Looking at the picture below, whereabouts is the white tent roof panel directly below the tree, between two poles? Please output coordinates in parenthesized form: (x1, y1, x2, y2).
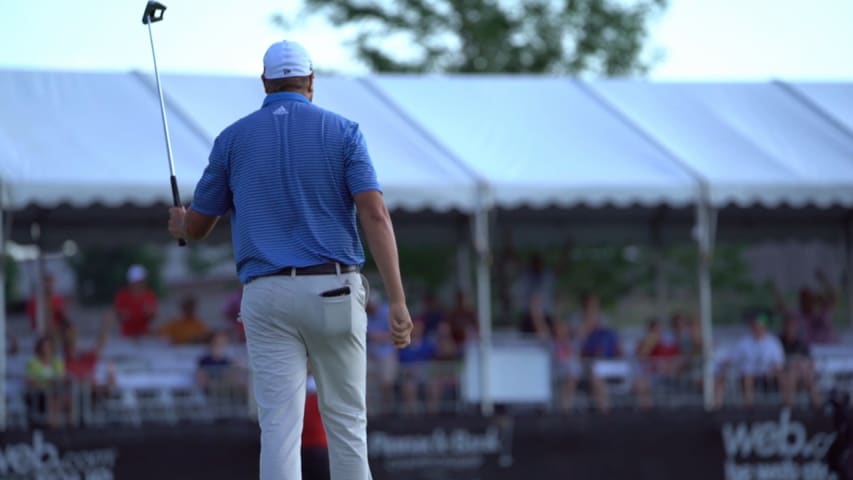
(370, 75, 696, 208)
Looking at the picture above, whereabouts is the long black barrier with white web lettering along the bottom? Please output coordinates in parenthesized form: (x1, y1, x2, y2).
(0, 408, 853, 480)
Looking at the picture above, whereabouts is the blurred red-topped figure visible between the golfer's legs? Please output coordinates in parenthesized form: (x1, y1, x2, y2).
(302, 368, 330, 480)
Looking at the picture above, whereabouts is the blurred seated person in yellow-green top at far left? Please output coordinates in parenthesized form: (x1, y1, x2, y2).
(27, 336, 71, 427)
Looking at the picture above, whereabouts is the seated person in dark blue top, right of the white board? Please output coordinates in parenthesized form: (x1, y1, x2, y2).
(581, 293, 622, 413)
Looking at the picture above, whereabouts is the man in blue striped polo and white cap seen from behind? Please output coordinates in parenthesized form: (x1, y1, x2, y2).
(169, 41, 412, 480)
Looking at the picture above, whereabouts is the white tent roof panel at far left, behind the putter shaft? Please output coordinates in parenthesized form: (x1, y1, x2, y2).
(0, 71, 208, 209)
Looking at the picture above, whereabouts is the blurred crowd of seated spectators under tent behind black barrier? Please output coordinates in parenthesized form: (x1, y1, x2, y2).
(6, 257, 853, 428)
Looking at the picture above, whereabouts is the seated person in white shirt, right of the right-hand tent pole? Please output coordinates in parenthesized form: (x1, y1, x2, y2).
(715, 311, 785, 408)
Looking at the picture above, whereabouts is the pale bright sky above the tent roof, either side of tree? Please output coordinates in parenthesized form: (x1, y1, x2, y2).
(0, 0, 853, 81)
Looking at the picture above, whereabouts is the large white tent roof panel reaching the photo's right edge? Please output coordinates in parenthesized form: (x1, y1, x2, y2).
(592, 80, 853, 207)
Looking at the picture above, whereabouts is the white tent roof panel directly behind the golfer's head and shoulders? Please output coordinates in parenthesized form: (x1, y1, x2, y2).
(151, 75, 476, 211)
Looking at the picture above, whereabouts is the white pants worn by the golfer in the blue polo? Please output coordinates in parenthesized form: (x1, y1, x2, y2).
(240, 273, 371, 480)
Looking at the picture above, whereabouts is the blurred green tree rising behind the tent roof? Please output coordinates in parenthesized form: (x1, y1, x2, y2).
(274, 0, 666, 76)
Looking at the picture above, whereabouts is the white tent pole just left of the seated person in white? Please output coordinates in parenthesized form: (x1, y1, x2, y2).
(696, 193, 717, 410)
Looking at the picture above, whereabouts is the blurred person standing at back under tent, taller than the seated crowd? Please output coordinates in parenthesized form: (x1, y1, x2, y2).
(519, 253, 555, 336)
